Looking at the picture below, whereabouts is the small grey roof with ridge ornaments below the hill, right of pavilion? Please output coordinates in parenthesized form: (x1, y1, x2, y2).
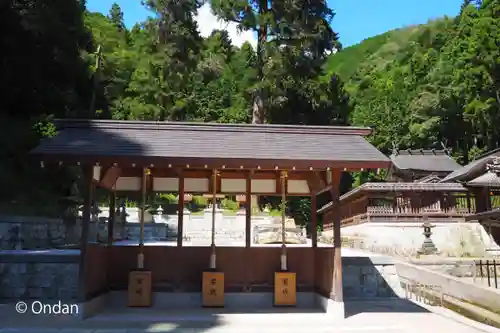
(390, 149, 461, 172)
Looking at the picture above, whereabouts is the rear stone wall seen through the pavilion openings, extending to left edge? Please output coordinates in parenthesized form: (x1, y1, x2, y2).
(0, 208, 278, 250)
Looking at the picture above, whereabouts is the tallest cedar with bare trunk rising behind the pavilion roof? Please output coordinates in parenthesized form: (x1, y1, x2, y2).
(211, 0, 336, 123)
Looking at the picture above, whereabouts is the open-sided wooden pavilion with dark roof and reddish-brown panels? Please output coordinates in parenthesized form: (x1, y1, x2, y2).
(32, 120, 390, 316)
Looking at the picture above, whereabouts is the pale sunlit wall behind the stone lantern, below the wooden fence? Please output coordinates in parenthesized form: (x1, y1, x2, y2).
(334, 220, 499, 257)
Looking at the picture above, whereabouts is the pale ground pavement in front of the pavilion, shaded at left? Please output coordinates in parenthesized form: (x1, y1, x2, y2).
(0, 300, 500, 333)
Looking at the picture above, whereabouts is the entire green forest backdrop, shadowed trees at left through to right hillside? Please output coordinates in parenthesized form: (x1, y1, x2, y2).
(0, 0, 500, 220)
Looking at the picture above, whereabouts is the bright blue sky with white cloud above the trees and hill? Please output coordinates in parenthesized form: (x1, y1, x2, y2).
(87, 0, 462, 47)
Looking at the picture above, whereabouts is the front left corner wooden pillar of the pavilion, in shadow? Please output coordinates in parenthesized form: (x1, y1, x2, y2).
(78, 166, 94, 302)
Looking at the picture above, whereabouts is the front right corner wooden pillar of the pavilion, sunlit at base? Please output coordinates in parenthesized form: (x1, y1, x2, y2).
(330, 169, 344, 302)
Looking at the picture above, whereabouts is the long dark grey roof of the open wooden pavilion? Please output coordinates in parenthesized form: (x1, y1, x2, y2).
(32, 120, 390, 169)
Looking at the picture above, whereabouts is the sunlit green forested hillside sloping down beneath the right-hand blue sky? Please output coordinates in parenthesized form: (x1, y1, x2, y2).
(327, 1, 500, 163)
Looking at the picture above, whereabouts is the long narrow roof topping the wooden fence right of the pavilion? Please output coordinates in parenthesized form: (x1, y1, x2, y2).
(318, 183, 467, 213)
